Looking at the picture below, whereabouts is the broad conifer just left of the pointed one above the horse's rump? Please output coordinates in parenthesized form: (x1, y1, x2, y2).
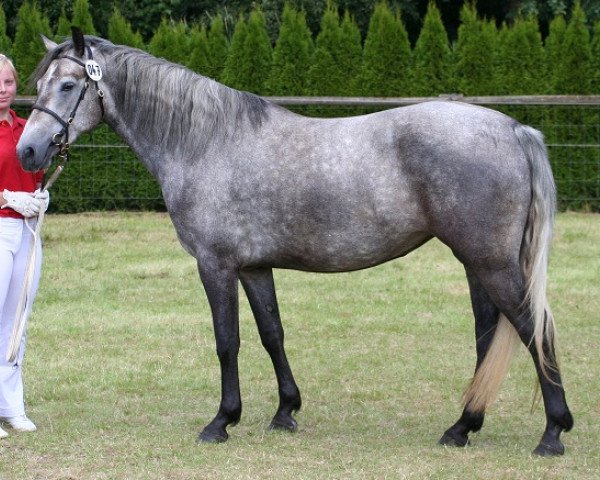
(356, 3, 411, 97)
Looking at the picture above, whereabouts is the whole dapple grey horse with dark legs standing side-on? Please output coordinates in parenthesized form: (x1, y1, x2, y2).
(18, 29, 573, 455)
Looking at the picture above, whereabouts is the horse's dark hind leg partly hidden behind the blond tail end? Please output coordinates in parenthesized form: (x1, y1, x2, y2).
(439, 269, 500, 447)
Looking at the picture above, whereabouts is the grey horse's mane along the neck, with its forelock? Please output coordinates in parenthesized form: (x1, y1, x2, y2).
(31, 35, 273, 155)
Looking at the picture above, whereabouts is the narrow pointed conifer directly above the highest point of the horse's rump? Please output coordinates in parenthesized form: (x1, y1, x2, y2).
(409, 2, 452, 96)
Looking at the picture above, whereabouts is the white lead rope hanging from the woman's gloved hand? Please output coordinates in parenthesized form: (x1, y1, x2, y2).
(6, 159, 68, 363)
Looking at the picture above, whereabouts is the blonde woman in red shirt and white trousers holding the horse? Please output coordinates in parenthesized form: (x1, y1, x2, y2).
(0, 54, 49, 438)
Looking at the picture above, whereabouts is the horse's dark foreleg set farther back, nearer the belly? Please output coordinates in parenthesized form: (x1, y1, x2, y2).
(240, 269, 302, 431)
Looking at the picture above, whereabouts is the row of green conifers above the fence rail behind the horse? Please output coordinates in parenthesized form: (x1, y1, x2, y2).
(0, 0, 600, 97)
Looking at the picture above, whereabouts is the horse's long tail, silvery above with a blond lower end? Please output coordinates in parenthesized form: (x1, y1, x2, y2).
(463, 124, 556, 412)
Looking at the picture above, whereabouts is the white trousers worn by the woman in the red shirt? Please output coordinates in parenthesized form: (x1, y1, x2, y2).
(0, 218, 42, 417)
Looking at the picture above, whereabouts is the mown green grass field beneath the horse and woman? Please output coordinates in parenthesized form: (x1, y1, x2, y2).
(0, 213, 600, 480)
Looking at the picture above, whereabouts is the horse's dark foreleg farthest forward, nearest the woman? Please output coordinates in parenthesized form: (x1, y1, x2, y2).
(198, 259, 242, 442)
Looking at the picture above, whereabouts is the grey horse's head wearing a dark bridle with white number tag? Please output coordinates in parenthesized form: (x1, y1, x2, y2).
(17, 27, 104, 171)
